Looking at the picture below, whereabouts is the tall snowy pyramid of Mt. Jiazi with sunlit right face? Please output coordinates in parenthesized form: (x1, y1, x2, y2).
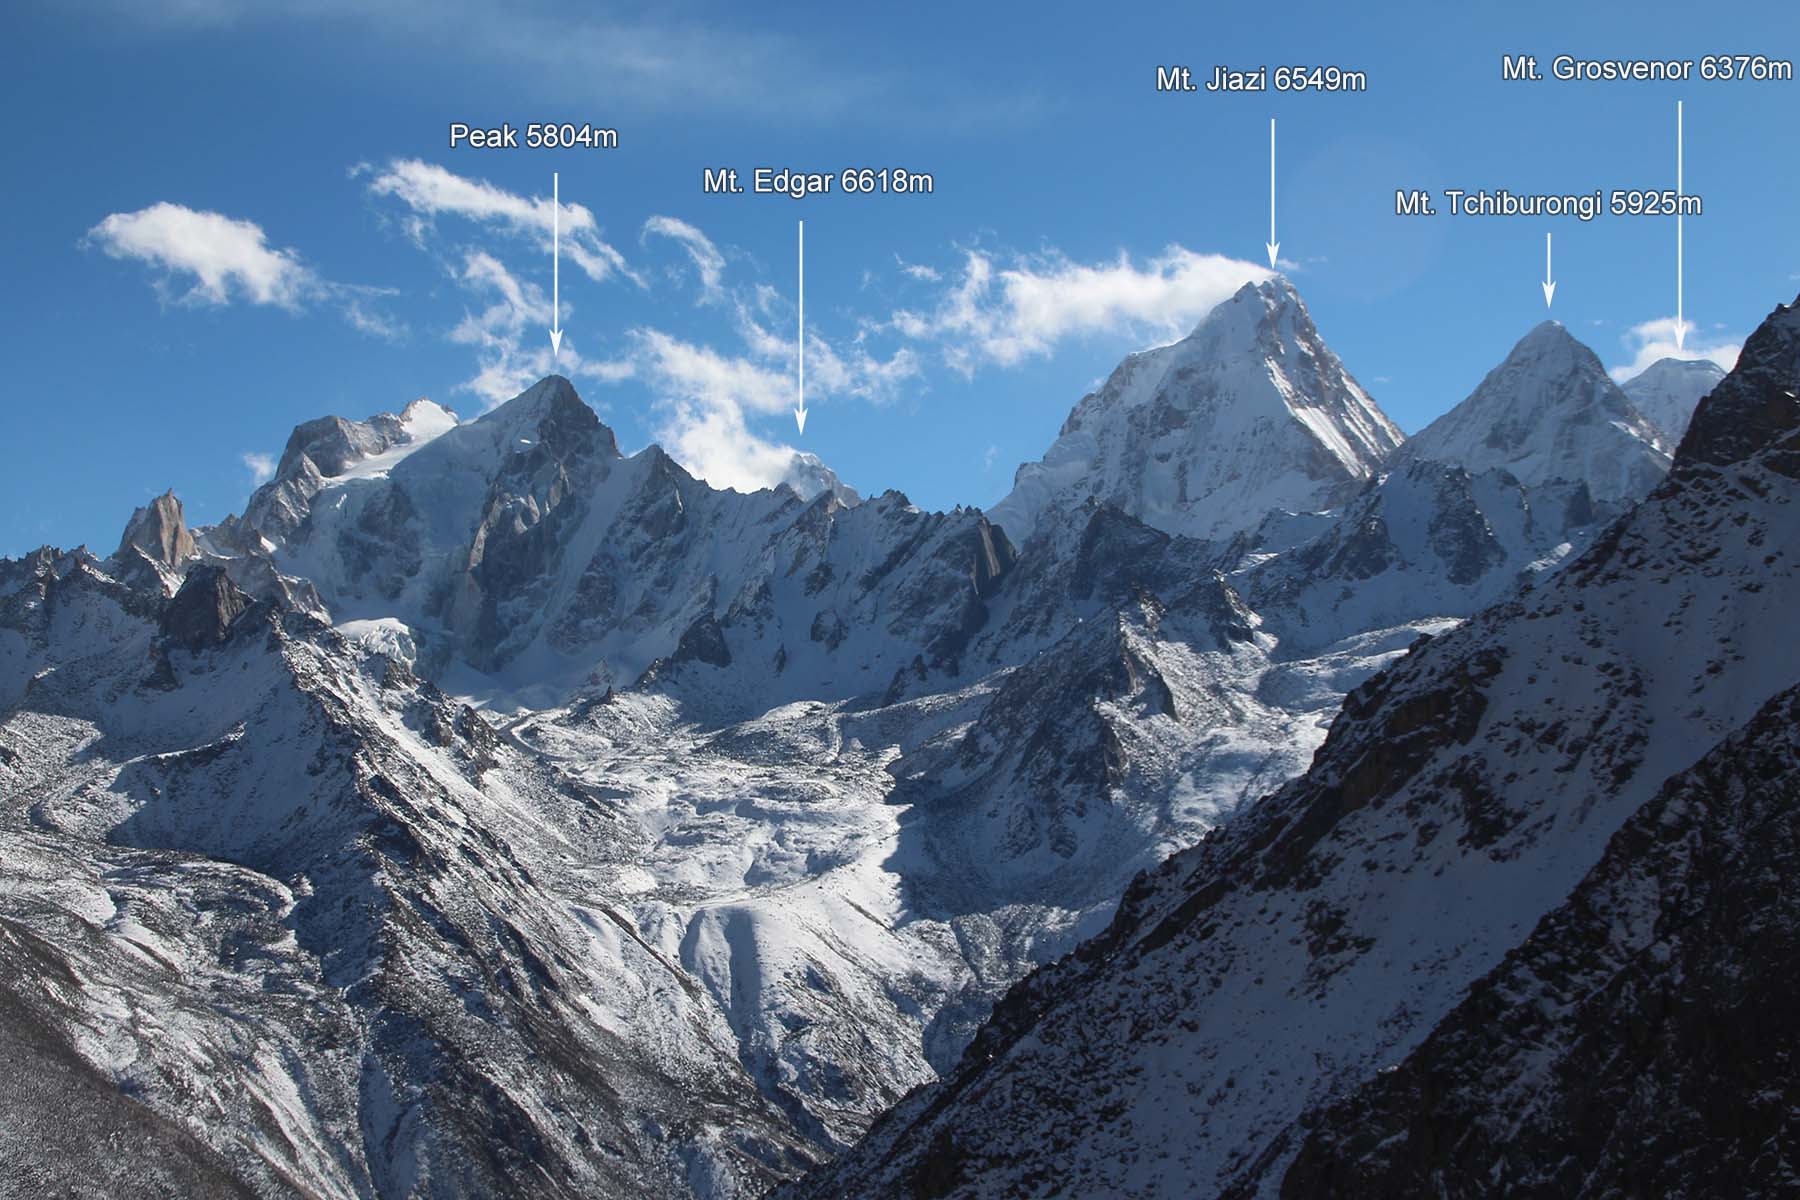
(990, 277, 1400, 545)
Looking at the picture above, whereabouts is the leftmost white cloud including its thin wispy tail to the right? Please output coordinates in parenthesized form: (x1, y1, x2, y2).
(81, 200, 405, 338)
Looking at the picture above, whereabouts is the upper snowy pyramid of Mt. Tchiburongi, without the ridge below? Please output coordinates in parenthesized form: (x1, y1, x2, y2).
(1404, 320, 1669, 500)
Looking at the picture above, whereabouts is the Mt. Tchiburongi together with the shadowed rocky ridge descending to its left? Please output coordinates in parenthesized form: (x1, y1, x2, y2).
(1237, 322, 1670, 651)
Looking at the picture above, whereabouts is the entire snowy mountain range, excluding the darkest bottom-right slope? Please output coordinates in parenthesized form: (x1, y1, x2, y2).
(0, 279, 1756, 1196)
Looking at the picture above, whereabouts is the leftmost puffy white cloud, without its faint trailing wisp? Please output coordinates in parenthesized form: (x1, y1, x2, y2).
(86, 201, 320, 311)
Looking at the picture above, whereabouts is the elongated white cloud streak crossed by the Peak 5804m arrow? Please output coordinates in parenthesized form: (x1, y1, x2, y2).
(369, 158, 643, 286)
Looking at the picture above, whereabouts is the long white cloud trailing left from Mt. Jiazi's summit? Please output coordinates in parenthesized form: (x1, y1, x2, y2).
(884, 246, 1273, 374)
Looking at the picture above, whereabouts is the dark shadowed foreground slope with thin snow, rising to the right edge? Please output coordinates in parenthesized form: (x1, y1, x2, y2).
(785, 293, 1800, 1196)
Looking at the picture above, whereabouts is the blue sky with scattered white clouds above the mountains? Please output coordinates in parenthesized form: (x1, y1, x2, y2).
(0, 0, 1800, 554)
